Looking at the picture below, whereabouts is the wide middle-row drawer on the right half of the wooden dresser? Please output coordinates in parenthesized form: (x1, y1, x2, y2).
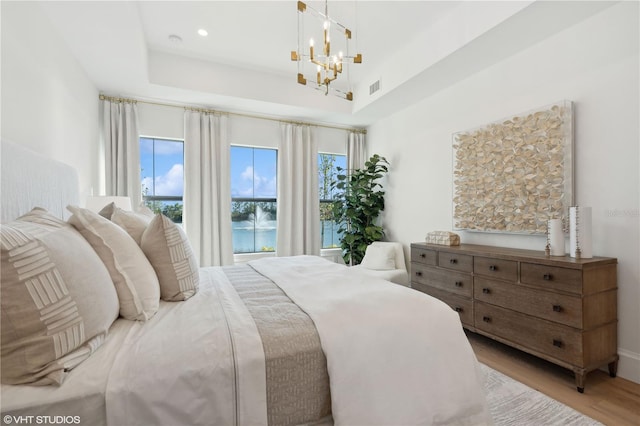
(473, 277, 582, 328)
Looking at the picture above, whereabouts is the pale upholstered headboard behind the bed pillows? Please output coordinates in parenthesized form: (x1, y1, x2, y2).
(0, 140, 79, 223)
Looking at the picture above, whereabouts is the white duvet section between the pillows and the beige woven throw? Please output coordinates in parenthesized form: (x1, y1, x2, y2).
(106, 268, 267, 426)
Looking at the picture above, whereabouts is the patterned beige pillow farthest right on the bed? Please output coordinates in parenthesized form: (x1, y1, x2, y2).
(142, 214, 199, 302)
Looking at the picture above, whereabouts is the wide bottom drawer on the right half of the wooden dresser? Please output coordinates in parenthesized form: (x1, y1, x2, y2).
(474, 302, 583, 365)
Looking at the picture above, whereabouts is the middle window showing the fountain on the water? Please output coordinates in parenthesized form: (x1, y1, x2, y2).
(231, 146, 278, 253)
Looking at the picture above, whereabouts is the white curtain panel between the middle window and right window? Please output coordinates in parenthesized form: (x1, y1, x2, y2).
(276, 123, 320, 256)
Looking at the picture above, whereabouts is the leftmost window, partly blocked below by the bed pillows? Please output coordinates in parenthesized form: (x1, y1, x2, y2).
(140, 137, 184, 223)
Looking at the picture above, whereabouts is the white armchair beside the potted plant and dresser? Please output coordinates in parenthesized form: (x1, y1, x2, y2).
(351, 241, 409, 286)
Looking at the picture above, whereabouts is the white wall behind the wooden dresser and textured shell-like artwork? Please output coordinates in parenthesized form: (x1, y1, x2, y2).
(368, 2, 640, 382)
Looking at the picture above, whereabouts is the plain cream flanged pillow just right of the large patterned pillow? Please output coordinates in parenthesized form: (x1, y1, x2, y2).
(67, 206, 160, 321)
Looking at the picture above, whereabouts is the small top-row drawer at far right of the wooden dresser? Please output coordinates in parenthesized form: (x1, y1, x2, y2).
(520, 262, 582, 294)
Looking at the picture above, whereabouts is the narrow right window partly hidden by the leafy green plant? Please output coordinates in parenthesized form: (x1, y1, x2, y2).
(318, 154, 347, 249)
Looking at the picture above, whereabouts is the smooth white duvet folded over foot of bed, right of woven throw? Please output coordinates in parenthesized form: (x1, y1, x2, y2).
(250, 256, 492, 425)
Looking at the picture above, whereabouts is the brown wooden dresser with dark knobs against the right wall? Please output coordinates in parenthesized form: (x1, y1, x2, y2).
(411, 243, 618, 392)
